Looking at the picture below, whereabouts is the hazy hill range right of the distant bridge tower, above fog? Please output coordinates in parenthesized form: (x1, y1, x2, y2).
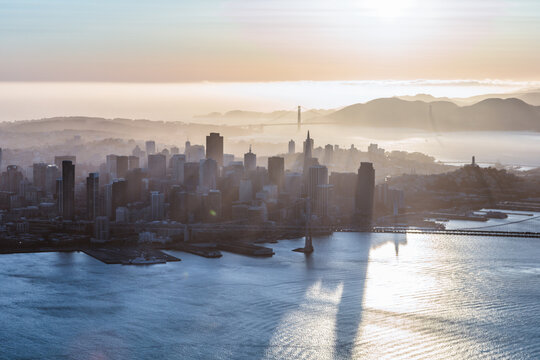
(322, 98, 540, 131)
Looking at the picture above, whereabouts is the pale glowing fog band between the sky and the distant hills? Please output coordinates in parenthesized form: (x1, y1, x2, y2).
(0, 80, 540, 121)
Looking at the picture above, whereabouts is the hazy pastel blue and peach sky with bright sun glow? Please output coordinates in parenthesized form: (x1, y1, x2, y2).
(0, 0, 540, 82)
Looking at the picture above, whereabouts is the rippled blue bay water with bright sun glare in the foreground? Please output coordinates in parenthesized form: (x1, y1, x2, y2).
(0, 233, 540, 359)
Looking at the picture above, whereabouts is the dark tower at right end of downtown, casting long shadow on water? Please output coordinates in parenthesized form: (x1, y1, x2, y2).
(355, 162, 375, 228)
